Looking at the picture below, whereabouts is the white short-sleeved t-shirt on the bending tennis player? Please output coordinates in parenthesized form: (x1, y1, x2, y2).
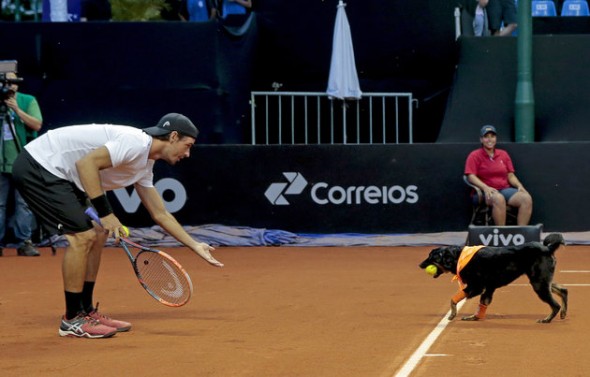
(25, 124, 154, 191)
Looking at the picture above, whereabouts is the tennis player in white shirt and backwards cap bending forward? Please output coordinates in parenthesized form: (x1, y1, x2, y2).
(13, 113, 223, 338)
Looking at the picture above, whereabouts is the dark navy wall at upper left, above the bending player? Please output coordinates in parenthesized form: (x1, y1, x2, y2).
(0, 21, 257, 144)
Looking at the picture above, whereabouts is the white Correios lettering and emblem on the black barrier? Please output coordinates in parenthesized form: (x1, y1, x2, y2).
(264, 172, 419, 205)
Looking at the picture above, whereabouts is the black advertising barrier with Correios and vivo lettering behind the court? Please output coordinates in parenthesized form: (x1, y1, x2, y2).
(109, 143, 590, 235)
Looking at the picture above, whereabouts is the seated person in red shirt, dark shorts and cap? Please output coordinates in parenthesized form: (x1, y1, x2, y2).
(465, 125, 533, 225)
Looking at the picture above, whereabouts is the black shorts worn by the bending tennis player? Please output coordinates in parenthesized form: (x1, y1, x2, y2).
(12, 149, 92, 235)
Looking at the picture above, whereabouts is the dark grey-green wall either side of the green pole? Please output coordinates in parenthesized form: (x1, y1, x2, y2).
(437, 36, 590, 143)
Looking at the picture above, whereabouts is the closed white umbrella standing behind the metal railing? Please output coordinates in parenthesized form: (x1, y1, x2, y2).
(327, 0, 362, 99)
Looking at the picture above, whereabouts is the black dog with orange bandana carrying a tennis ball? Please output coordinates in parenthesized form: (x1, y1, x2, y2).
(420, 233, 568, 323)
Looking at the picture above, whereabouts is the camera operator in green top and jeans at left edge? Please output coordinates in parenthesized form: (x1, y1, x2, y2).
(0, 72, 43, 256)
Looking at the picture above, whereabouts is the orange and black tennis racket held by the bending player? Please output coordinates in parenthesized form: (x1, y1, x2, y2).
(86, 207, 193, 307)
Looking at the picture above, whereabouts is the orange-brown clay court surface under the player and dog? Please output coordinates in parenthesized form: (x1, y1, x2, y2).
(0, 242, 590, 377)
